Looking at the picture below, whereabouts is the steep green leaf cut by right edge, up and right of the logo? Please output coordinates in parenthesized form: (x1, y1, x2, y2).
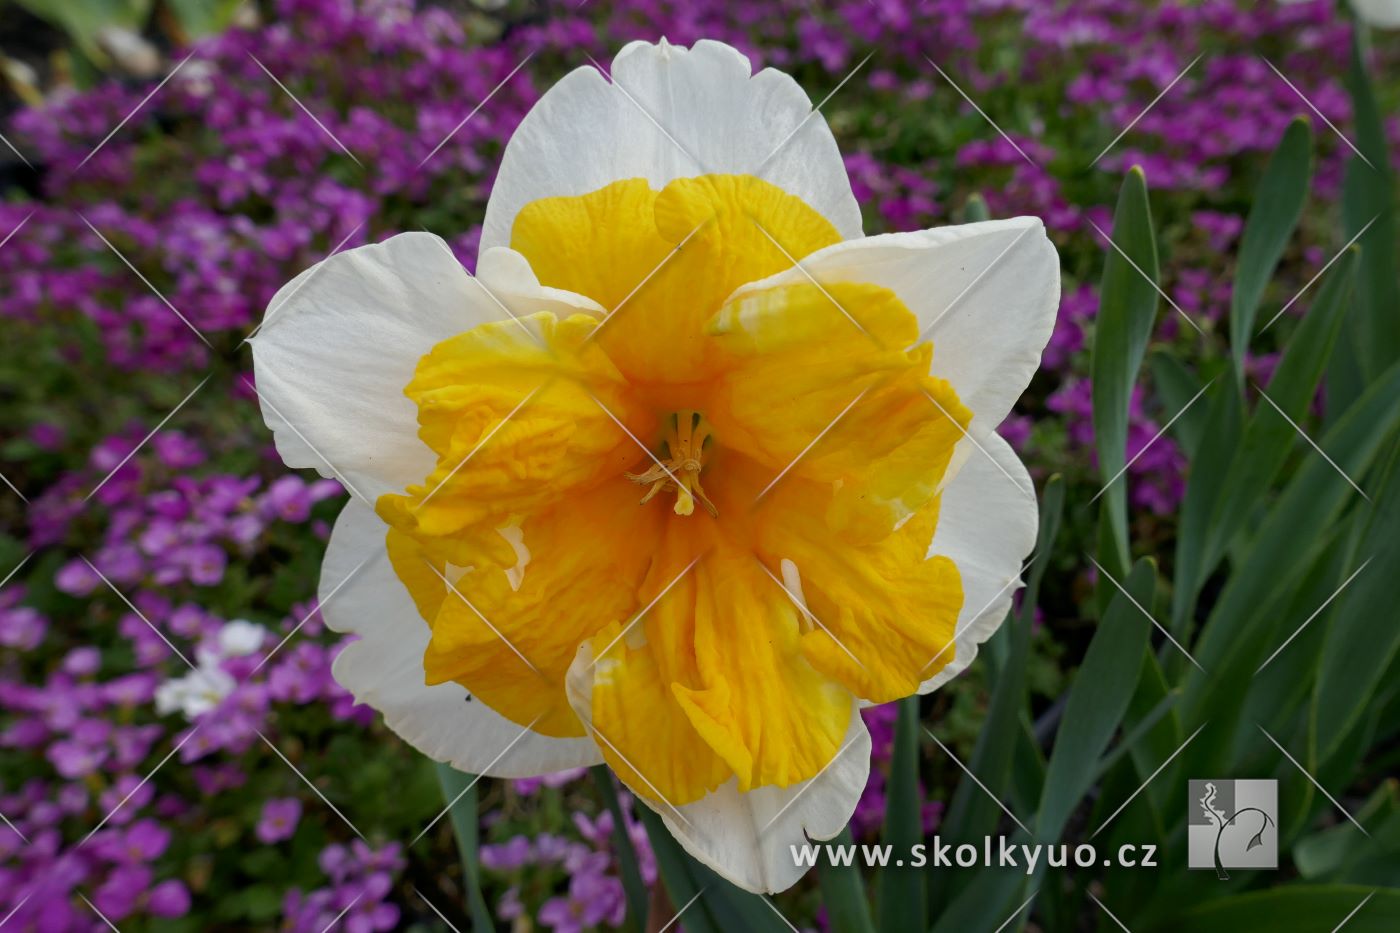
(1312, 444, 1400, 759)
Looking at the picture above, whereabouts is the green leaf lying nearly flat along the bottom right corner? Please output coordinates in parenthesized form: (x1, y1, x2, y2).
(1151, 884, 1400, 933)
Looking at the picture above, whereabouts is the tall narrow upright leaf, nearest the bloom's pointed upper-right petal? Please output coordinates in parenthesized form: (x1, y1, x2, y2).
(1091, 167, 1158, 574)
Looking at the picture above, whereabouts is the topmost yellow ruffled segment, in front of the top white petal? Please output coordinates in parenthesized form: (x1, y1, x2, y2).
(511, 175, 840, 383)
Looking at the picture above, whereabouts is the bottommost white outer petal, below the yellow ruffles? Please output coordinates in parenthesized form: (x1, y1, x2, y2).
(643, 705, 871, 894)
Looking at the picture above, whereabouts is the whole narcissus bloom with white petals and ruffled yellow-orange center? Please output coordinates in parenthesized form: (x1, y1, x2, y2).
(253, 42, 1058, 891)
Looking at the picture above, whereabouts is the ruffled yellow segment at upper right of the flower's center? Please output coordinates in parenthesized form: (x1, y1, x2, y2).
(706, 283, 972, 544)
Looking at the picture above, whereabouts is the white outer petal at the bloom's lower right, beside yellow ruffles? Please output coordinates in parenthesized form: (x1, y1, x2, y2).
(918, 430, 1039, 693)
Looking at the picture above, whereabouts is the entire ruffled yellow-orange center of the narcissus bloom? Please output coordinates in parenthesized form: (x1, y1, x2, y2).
(378, 175, 970, 806)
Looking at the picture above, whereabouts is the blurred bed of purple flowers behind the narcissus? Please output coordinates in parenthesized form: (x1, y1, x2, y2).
(0, 0, 1400, 932)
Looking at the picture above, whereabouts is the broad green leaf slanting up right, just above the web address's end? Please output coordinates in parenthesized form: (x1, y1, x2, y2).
(1036, 559, 1156, 842)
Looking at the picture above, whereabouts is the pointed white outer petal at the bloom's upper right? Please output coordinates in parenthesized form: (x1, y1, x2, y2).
(735, 217, 1060, 433)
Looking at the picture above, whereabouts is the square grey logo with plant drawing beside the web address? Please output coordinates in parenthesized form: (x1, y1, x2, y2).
(1186, 780, 1278, 880)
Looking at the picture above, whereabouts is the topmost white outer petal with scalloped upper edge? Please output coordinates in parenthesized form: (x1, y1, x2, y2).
(482, 39, 861, 249)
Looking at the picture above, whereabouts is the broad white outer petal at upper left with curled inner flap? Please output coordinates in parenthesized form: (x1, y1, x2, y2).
(252, 233, 602, 502)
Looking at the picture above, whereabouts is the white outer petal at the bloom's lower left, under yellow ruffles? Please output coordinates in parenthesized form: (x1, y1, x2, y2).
(319, 500, 602, 778)
